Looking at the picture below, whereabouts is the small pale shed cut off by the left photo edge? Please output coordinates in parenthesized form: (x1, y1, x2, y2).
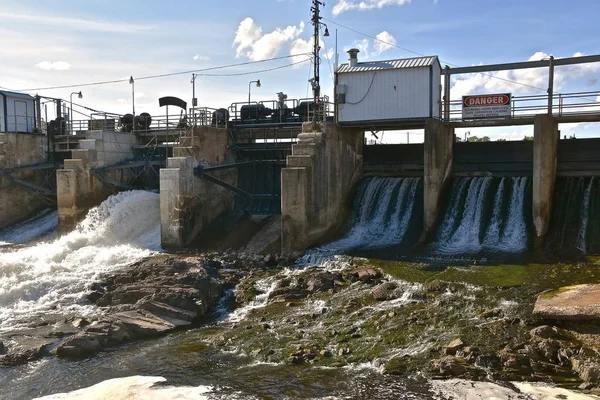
(0, 90, 35, 133)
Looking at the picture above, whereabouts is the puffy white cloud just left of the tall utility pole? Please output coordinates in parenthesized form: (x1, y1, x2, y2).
(233, 17, 304, 61)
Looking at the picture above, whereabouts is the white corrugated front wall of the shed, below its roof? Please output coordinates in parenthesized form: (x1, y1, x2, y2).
(338, 67, 432, 122)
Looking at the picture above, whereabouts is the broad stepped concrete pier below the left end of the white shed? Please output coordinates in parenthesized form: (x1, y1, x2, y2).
(281, 123, 364, 255)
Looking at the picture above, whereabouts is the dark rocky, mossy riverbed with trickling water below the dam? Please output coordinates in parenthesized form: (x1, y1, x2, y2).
(0, 253, 600, 393)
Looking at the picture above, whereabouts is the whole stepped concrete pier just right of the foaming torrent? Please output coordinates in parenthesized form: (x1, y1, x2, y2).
(160, 127, 237, 248)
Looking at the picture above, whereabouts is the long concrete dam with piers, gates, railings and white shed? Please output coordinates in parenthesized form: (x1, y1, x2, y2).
(0, 51, 600, 257)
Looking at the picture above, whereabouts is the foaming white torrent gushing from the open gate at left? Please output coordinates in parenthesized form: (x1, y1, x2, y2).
(0, 191, 160, 330)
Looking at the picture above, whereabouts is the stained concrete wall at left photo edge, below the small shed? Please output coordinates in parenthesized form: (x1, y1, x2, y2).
(0, 133, 48, 229)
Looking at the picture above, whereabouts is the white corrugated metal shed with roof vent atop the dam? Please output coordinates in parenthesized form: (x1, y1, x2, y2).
(336, 49, 442, 126)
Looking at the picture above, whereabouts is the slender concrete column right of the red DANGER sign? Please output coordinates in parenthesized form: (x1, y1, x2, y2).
(533, 115, 558, 247)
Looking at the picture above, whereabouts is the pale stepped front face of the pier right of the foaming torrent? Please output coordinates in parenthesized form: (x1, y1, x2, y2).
(160, 157, 194, 248)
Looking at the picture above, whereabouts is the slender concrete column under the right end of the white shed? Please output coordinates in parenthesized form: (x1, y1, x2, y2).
(422, 120, 454, 239)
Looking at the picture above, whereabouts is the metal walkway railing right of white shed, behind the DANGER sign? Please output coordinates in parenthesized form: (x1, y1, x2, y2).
(442, 91, 600, 122)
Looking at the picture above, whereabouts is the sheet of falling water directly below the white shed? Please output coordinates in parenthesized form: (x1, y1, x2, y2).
(303, 178, 420, 264)
